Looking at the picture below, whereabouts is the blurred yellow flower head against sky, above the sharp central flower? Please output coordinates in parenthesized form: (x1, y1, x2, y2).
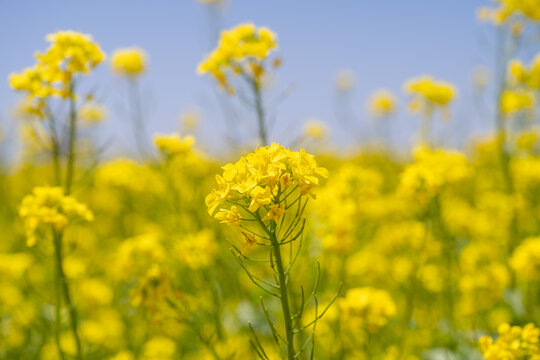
(197, 23, 277, 93)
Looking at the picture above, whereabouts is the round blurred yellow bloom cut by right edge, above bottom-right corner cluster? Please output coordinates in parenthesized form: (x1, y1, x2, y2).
(510, 237, 540, 281)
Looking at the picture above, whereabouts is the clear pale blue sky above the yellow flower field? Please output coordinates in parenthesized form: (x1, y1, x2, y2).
(0, 0, 493, 156)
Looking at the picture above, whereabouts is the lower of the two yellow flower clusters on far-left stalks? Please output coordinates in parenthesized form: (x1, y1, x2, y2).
(19, 186, 94, 246)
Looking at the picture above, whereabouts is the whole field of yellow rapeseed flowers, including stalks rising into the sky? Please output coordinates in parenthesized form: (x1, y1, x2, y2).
(0, 0, 540, 360)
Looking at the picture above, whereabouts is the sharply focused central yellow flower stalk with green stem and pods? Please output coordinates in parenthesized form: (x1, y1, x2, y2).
(206, 143, 335, 360)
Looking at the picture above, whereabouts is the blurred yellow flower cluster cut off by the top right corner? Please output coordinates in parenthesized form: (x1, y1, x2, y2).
(478, 0, 540, 25)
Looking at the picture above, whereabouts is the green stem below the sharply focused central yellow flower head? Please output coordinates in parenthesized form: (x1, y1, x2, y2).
(270, 227, 295, 360)
